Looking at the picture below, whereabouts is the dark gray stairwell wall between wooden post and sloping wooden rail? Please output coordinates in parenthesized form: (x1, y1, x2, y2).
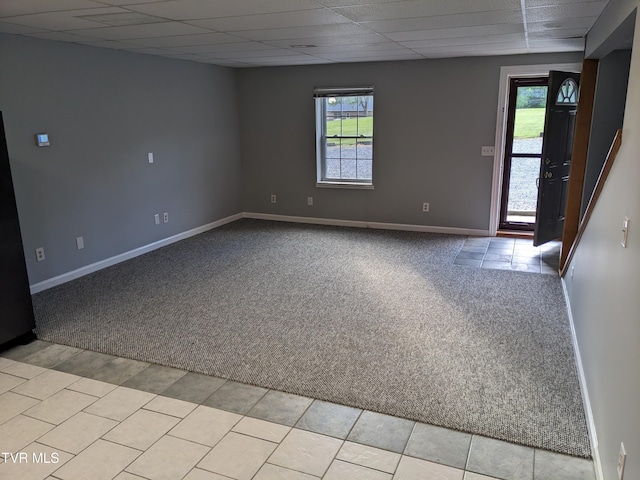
(582, 50, 631, 215)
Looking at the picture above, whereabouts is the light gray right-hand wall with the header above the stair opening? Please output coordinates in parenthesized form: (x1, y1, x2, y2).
(566, 0, 640, 480)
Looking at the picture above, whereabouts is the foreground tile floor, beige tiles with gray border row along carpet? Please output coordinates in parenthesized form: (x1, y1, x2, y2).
(0, 341, 595, 480)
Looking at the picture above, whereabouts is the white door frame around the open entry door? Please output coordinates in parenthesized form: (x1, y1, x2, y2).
(489, 63, 582, 237)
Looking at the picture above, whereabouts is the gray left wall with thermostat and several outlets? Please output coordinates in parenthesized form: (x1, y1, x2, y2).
(0, 35, 242, 284)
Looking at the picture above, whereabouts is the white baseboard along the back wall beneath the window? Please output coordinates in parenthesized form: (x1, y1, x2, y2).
(243, 212, 489, 237)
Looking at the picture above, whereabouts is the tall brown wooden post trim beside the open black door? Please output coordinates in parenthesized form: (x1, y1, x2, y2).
(560, 59, 598, 270)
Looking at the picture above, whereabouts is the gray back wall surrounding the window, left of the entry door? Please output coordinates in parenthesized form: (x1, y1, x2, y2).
(238, 53, 582, 230)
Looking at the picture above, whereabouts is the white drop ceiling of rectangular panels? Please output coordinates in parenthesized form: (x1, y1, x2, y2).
(0, 0, 607, 68)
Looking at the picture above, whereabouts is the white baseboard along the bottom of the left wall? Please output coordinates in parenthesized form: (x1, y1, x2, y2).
(31, 213, 243, 294)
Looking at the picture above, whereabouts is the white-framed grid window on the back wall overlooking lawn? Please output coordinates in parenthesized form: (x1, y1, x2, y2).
(314, 87, 373, 188)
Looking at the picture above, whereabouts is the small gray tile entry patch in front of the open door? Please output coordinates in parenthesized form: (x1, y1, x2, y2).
(454, 237, 562, 275)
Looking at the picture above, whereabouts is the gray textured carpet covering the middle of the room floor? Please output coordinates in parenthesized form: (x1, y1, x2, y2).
(34, 220, 590, 457)
